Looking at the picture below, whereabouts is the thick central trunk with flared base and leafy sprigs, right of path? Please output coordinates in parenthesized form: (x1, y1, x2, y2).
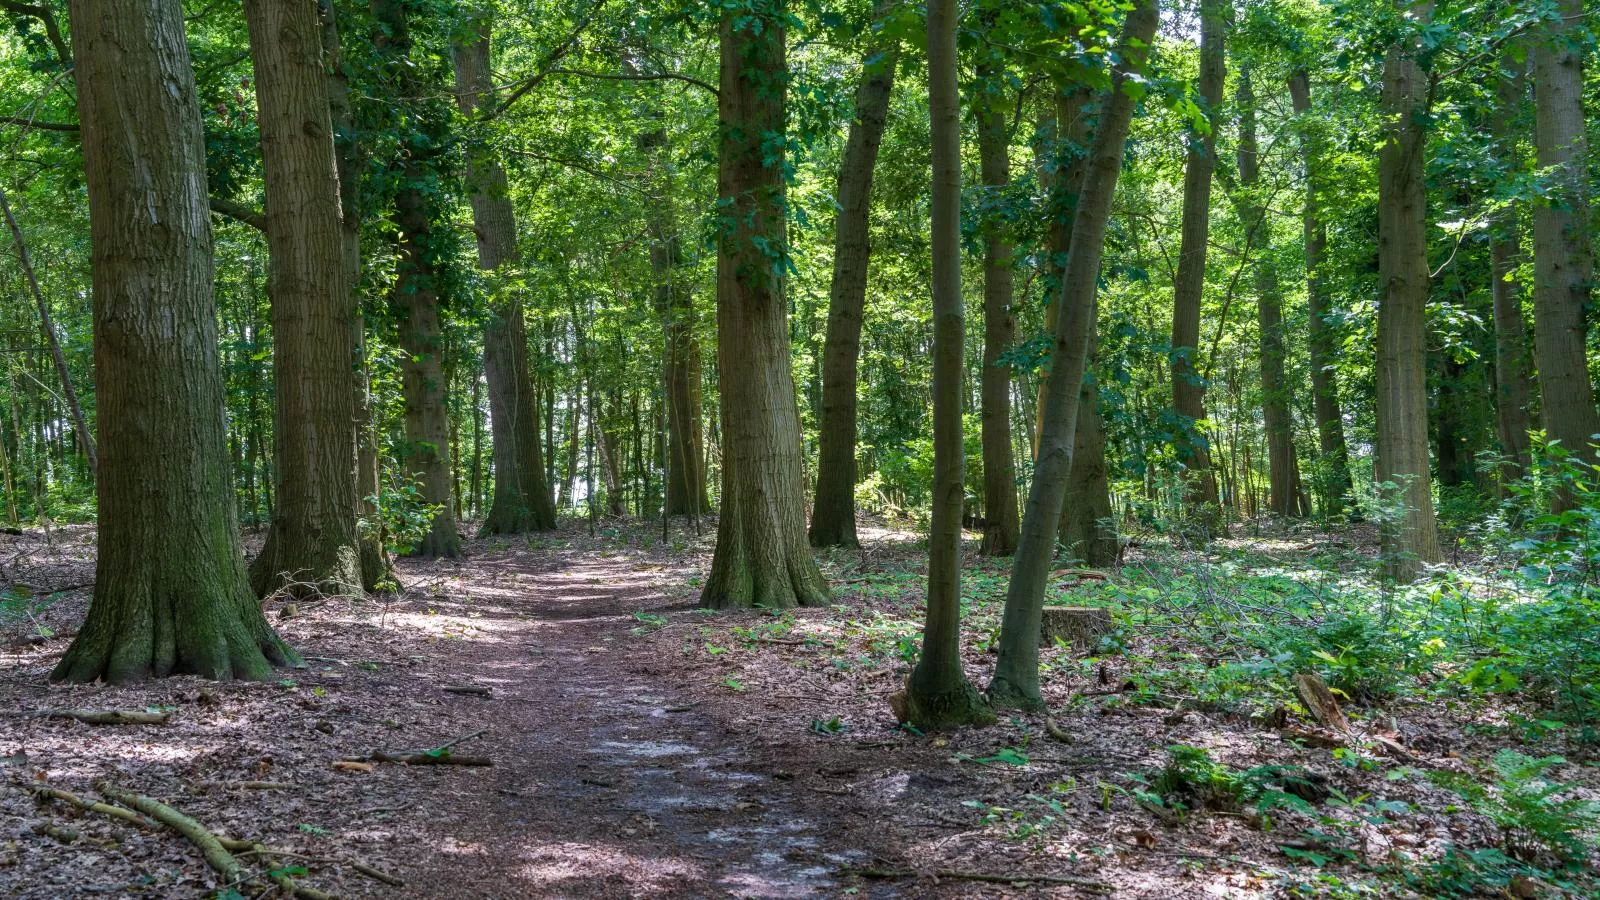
(701, 3, 827, 609)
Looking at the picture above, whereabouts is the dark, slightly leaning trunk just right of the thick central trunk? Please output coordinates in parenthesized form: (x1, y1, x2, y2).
(812, 21, 899, 546)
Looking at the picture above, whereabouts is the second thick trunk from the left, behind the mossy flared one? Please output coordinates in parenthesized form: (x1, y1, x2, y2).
(245, 0, 365, 596)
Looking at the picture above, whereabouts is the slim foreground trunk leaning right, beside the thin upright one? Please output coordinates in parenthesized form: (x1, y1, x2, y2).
(989, 0, 1160, 709)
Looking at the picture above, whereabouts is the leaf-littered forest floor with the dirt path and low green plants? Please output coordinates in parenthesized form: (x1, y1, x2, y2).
(0, 524, 1600, 898)
